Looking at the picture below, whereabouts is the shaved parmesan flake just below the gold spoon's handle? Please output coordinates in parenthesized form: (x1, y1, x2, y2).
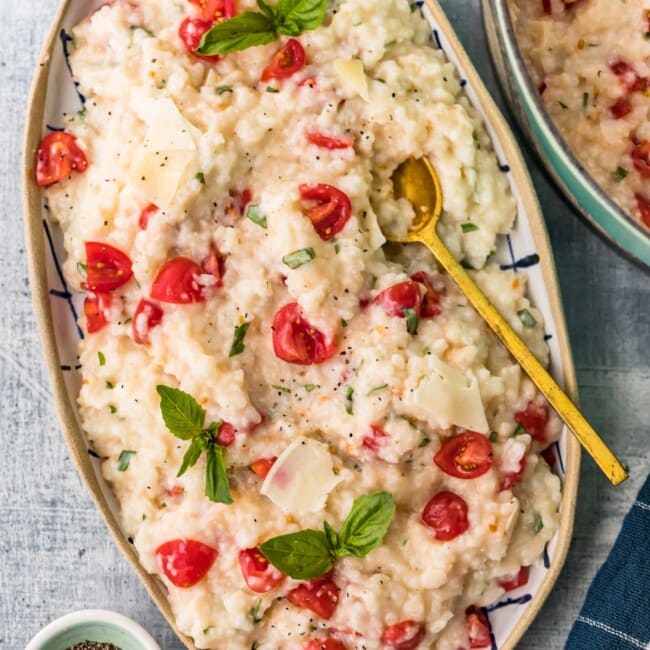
(405, 355, 489, 433)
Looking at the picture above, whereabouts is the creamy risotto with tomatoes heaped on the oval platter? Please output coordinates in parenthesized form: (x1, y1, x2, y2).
(37, 0, 560, 650)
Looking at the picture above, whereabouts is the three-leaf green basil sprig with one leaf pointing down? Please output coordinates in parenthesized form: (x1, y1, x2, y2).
(156, 384, 233, 504)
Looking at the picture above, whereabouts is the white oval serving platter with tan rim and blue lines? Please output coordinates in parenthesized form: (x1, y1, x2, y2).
(23, 0, 580, 650)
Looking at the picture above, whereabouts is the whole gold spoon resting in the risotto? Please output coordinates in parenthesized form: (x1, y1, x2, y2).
(386, 157, 627, 485)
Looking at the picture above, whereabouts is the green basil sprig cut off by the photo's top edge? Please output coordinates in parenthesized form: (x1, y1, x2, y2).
(197, 0, 327, 56)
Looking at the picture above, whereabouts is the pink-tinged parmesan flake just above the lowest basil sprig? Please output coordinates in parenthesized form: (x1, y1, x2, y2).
(260, 438, 343, 513)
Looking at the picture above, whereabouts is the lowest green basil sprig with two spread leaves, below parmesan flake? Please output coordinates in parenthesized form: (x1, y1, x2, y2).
(260, 492, 395, 580)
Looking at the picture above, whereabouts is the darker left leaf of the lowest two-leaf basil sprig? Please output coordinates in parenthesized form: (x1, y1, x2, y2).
(260, 529, 334, 580)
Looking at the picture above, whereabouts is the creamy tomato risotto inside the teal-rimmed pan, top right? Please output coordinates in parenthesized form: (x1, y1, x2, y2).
(510, 0, 650, 227)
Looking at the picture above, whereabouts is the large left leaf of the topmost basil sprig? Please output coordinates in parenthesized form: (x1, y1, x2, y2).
(197, 11, 278, 56)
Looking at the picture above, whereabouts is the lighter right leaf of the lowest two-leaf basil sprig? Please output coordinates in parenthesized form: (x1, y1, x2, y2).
(335, 492, 395, 557)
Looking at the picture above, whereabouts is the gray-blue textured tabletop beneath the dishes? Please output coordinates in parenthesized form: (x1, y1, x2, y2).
(0, 0, 650, 650)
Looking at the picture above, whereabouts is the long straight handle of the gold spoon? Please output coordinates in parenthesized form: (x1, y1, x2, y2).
(416, 228, 627, 485)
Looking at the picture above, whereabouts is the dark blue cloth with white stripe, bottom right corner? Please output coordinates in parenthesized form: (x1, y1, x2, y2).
(565, 470, 650, 650)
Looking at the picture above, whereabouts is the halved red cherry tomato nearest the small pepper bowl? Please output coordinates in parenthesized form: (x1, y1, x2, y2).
(156, 539, 218, 589)
